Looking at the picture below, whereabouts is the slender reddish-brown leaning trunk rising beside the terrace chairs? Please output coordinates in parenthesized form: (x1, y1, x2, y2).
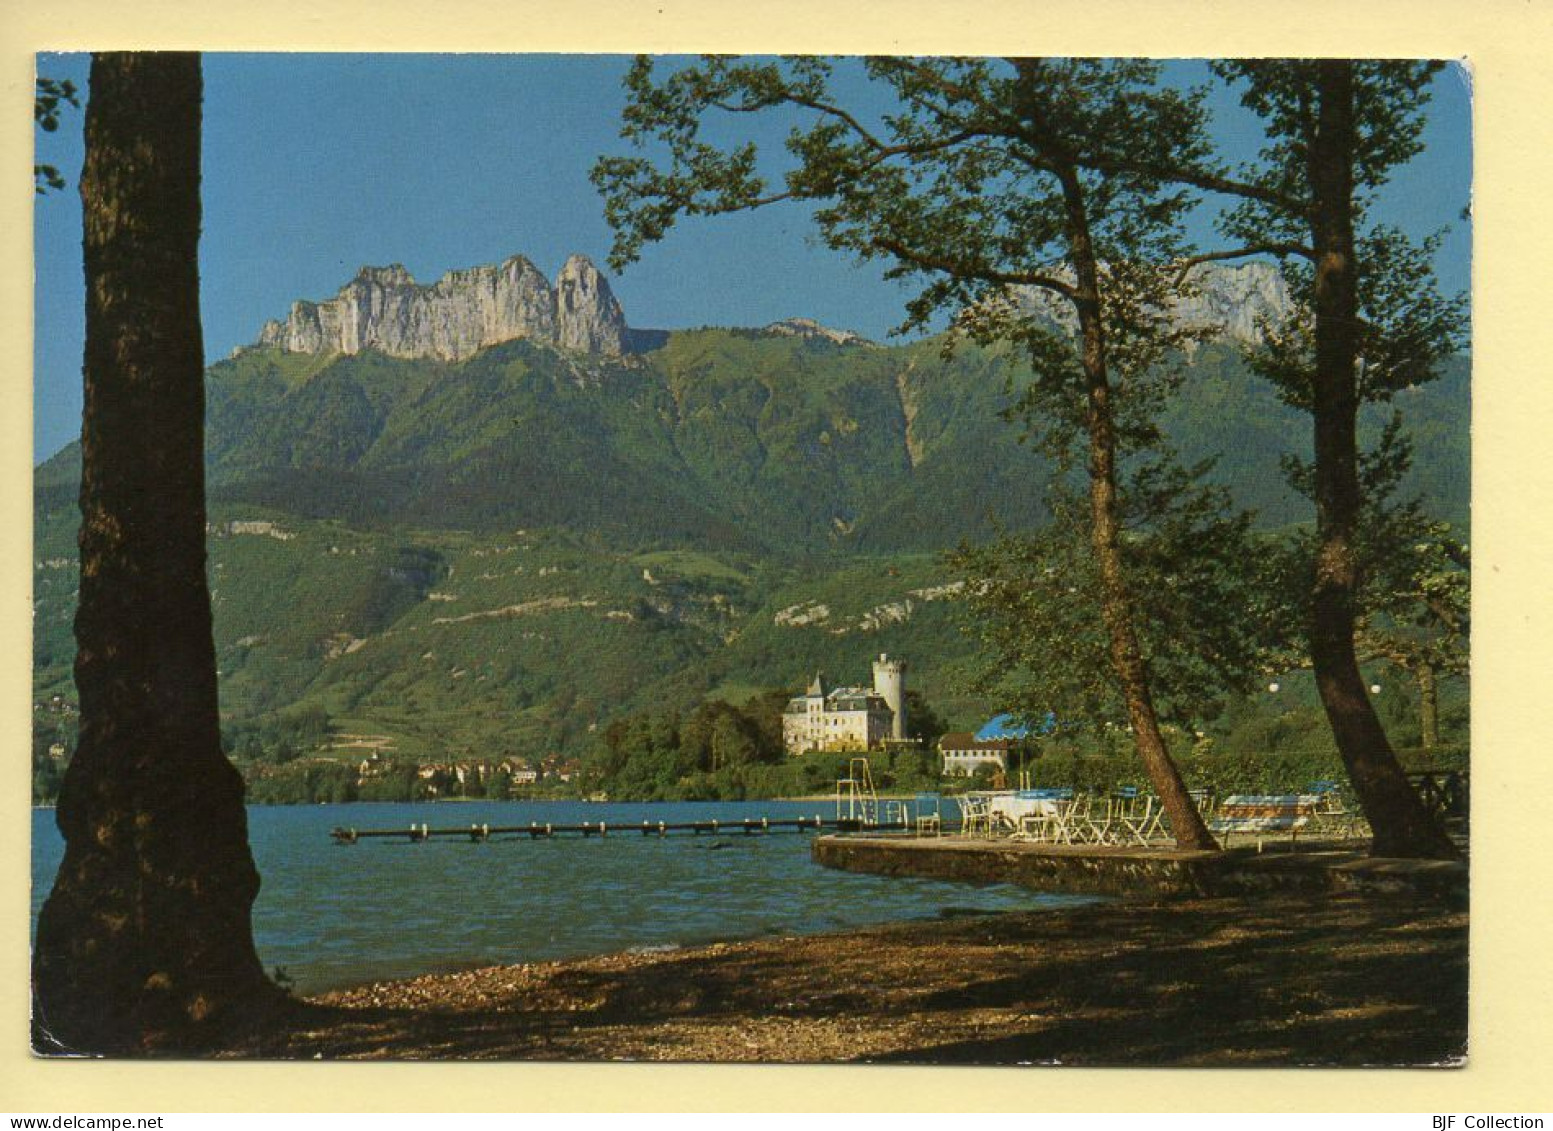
(1059, 169, 1218, 848)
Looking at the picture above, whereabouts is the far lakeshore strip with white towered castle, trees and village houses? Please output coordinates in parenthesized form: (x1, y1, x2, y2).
(33, 654, 1039, 803)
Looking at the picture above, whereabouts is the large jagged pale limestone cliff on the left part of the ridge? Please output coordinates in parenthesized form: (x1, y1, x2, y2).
(258, 255, 629, 360)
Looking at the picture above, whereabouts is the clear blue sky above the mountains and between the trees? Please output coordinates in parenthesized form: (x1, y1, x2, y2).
(34, 54, 1471, 461)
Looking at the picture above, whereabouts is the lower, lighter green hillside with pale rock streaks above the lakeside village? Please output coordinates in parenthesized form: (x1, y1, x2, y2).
(34, 505, 981, 758)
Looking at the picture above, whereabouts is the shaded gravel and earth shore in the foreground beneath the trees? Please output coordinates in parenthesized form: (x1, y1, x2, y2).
(228, 895, 1468, 1067)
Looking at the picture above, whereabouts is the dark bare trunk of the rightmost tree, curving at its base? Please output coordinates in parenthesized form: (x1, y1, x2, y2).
(1308, 61, 1458, 858)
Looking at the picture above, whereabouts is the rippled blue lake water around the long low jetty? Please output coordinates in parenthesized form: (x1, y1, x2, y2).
(33, 802, 1090, 993)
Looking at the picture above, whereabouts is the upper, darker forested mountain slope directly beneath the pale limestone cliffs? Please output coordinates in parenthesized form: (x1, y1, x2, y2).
(187, 329, 1469, 546)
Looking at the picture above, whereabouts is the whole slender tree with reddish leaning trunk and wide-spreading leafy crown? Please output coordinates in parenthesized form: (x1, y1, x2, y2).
(593, 57, 1273, 845)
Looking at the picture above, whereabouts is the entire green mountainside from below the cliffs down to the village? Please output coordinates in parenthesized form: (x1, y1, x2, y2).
(34, 329, 1469, 783)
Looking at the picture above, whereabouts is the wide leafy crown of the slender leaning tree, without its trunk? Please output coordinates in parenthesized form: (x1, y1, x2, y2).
(593, 57, 1207, 340)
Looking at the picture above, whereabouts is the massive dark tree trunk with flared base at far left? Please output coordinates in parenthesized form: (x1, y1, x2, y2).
(33, 53, 278, 1053)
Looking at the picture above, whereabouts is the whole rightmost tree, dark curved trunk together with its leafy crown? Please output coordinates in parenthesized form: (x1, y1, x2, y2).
(1180, 59, 1466, 856)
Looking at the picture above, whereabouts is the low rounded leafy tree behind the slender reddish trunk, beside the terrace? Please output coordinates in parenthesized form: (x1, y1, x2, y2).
(950, 460, 1280, 730)
